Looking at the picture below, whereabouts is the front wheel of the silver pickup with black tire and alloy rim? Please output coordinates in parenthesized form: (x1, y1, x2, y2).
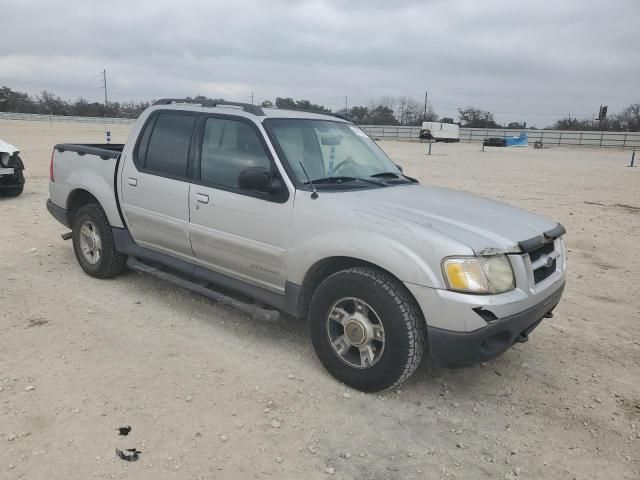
(309, 267, 426, 392)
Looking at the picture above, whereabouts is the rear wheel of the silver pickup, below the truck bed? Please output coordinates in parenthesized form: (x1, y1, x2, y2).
(72, 203, 127, 278)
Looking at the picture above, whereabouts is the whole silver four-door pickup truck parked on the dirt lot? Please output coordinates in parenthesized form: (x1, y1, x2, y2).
(47, 99, 566, 392)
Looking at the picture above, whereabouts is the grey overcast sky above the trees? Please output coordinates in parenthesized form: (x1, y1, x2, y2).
(0, 0, 640, 126)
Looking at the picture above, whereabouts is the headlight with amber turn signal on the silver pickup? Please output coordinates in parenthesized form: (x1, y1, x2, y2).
(442, 255, 515, 293)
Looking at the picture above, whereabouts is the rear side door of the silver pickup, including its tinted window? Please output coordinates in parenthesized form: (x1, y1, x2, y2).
(121, 110, 198, 257)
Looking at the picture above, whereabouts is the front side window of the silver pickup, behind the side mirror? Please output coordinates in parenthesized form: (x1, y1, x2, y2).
(200, 118, 271, 188)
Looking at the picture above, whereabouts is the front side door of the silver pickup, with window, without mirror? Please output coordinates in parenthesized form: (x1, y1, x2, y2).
(189, 115, 293, 293)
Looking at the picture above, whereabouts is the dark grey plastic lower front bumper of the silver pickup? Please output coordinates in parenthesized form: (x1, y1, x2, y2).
(427, 281, 565, 368)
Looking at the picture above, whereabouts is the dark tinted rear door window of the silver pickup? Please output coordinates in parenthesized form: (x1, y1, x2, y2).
(144, 113, 196, 177)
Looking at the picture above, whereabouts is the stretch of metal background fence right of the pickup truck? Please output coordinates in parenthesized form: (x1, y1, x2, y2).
(360, 125, 640, 148)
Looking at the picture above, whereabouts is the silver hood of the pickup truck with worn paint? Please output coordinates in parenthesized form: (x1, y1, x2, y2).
(344, 185, 557, 255)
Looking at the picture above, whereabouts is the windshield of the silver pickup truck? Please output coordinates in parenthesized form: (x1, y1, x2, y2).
(265, 119, 406, 186)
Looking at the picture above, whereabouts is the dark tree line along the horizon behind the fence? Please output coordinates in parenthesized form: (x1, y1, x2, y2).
(0, 87, 640, 132)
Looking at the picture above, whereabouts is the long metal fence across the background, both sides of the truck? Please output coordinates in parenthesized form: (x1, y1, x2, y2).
(0, 112, 640, 148)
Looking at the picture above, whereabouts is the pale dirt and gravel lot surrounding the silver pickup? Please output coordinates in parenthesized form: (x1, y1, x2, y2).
(0, 117, 640, 479)
